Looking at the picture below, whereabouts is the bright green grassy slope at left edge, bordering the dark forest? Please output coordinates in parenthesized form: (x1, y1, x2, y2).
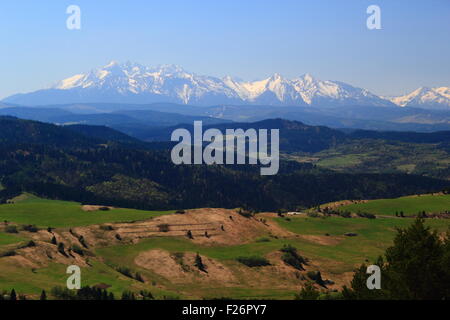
(0, 196, 172, 228)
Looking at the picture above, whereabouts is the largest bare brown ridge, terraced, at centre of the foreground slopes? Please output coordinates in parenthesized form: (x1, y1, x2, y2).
(29, 208, 312, 247)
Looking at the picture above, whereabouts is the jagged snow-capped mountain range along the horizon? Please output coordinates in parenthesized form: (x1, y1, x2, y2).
(3, 62, 450, 109)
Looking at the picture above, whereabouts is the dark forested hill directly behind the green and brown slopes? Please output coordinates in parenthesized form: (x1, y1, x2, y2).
(0, 118, 450, 210)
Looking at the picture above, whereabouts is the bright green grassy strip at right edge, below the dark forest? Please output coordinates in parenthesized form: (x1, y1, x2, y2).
(339, 194, 450, 216)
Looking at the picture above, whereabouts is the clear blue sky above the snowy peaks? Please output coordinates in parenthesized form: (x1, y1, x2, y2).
(0, 0, 450, 99)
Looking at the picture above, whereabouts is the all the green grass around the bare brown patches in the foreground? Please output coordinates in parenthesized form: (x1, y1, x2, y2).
(0, 195, 450, 299)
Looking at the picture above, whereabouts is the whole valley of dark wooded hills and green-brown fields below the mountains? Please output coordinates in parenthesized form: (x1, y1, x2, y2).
(0, 104, 450, 300)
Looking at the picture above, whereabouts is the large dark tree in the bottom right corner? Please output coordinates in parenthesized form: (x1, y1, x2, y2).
(342, 218, 450, 300)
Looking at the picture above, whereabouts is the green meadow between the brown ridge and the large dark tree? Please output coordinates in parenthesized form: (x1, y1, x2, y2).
(97, 217, 450, 272)
